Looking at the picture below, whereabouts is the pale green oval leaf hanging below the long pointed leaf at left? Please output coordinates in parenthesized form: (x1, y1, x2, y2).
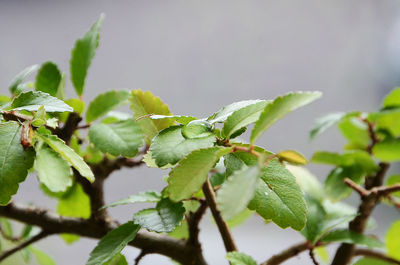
(35, 143, 72, 192)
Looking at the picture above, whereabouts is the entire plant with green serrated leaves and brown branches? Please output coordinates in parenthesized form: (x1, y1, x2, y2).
(0, 13, 400, 265)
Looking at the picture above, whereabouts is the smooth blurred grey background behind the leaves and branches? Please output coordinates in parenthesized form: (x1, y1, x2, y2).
(0, 0, 400, 265)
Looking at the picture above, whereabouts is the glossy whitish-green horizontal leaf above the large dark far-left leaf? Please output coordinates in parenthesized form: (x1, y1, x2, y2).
(11, 91, 72, 112)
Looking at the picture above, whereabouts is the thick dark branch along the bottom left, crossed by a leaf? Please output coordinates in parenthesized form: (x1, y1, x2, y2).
(0, 204, 207, 265)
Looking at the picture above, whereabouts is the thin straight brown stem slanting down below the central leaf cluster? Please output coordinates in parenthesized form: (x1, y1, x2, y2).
(203, 178, 237, 252)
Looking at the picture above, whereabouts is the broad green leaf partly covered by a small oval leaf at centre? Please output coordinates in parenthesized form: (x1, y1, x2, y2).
(150, 125, 216, 167)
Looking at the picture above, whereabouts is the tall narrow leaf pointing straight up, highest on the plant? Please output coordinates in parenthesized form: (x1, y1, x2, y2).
(70, 14, 104, 96)
